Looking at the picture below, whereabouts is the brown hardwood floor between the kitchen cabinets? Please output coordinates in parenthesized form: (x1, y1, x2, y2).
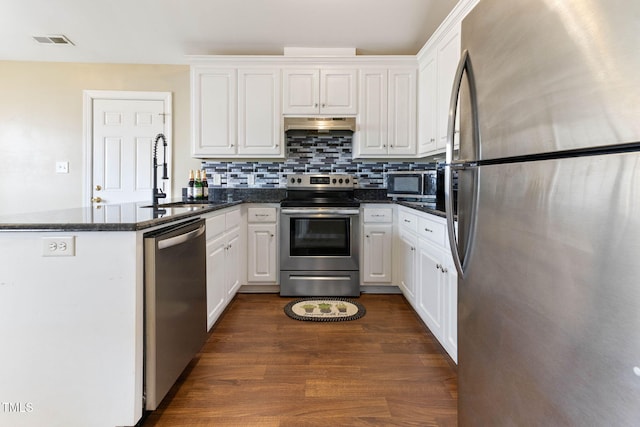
(143, 294, 457, 427)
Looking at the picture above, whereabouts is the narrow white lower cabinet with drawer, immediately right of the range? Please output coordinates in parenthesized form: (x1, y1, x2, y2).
(360, 205, 393, 285)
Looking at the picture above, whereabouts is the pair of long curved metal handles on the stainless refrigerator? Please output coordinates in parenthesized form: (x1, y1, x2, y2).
(444, 50, 480, 279)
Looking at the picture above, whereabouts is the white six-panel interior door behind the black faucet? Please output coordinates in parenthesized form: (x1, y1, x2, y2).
(89, 99, 171, 204)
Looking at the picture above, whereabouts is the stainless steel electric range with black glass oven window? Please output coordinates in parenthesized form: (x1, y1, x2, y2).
(280, 174, 360, 296)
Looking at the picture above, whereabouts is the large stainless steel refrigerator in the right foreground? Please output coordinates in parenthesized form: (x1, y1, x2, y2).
(447, 0, 640, 426)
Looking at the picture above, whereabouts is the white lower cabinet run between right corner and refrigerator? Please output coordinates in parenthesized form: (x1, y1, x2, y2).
(396, 206, 458, 363)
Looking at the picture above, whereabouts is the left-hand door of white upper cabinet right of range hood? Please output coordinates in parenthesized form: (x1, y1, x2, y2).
(353, 69, 388, 157)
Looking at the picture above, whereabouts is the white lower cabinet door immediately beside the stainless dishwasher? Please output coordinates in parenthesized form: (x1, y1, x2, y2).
(207, 236, 227, 329)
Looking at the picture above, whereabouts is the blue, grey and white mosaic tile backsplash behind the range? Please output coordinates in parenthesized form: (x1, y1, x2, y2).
(202, 132, 436, 188)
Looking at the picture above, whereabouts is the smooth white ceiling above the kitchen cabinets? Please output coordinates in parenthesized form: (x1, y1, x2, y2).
(0, 0, 457, 64)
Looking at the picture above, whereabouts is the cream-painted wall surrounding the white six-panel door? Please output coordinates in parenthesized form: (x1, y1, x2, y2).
(0, 61, 200, 215)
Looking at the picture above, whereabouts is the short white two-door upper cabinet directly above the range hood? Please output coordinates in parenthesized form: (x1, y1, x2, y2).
(282, 68, 358, 115)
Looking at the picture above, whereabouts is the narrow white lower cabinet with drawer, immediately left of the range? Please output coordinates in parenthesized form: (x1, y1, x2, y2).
(247, 207, 279, 285)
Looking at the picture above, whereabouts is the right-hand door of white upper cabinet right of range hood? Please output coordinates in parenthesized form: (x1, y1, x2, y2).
(388, 68, 416, 156)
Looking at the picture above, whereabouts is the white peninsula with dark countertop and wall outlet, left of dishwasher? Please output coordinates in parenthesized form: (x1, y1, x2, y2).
(0, 202, 241, 426)
